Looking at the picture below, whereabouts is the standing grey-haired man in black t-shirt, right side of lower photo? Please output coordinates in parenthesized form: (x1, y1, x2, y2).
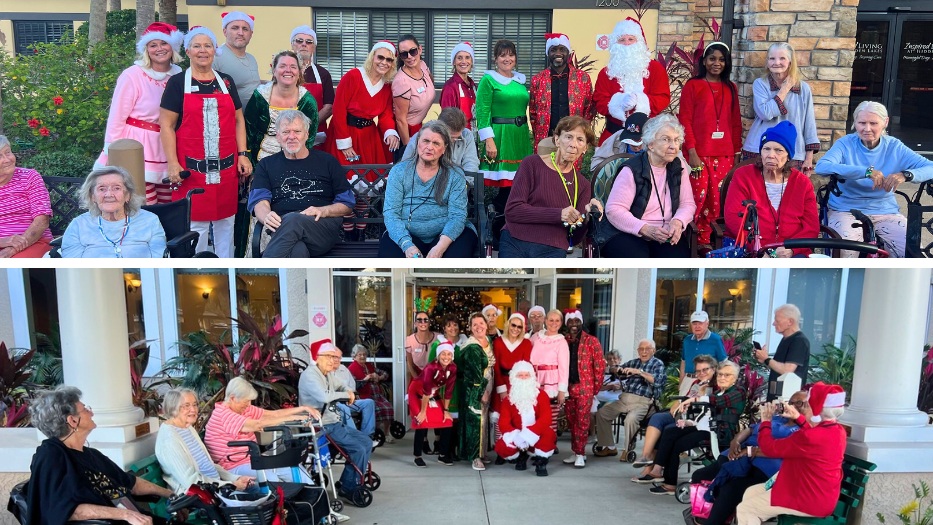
(755, 304, 810, 401)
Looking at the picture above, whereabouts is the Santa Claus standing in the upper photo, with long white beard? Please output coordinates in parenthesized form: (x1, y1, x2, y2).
(593, 17, 671, 144)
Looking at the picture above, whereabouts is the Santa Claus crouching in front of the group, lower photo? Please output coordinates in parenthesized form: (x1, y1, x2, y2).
(496, 361, 557, 476)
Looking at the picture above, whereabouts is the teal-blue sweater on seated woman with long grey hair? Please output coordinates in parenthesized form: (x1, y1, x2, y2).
(383, 159, 475, 251)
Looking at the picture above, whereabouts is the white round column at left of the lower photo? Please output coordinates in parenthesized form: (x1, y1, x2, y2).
(55, 268, 144, 428)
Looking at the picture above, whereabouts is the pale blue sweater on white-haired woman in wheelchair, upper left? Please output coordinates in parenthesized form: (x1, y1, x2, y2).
(62, 210, 165, 259)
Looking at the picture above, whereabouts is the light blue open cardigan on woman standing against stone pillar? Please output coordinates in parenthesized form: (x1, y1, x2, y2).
(742, 78, 820, 160)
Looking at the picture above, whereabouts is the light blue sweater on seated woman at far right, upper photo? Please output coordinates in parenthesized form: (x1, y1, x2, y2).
(815, 133, 933, 215)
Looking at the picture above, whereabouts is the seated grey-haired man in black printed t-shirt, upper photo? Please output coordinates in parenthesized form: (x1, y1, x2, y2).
(246, 110, 356, 257)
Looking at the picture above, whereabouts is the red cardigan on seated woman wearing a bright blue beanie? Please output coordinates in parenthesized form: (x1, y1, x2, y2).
(723, 165, 820, 255)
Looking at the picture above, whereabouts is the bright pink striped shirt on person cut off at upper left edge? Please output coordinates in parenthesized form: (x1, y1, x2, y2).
(0, 168, 52, 241)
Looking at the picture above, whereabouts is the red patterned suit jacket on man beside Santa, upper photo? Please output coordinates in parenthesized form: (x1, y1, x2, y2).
(528, 66, 596, 148)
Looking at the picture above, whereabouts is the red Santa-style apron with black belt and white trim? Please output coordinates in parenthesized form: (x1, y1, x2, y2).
(172, 69, 239, 221)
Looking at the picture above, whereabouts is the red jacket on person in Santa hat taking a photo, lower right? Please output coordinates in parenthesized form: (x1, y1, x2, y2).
(758, 421, 846, 517)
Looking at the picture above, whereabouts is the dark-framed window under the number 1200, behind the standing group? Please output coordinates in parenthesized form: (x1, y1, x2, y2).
(314, 9, 551, 88)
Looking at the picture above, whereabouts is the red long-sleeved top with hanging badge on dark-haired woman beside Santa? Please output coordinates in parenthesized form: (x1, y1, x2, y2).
(677, 78, 742, 157)
